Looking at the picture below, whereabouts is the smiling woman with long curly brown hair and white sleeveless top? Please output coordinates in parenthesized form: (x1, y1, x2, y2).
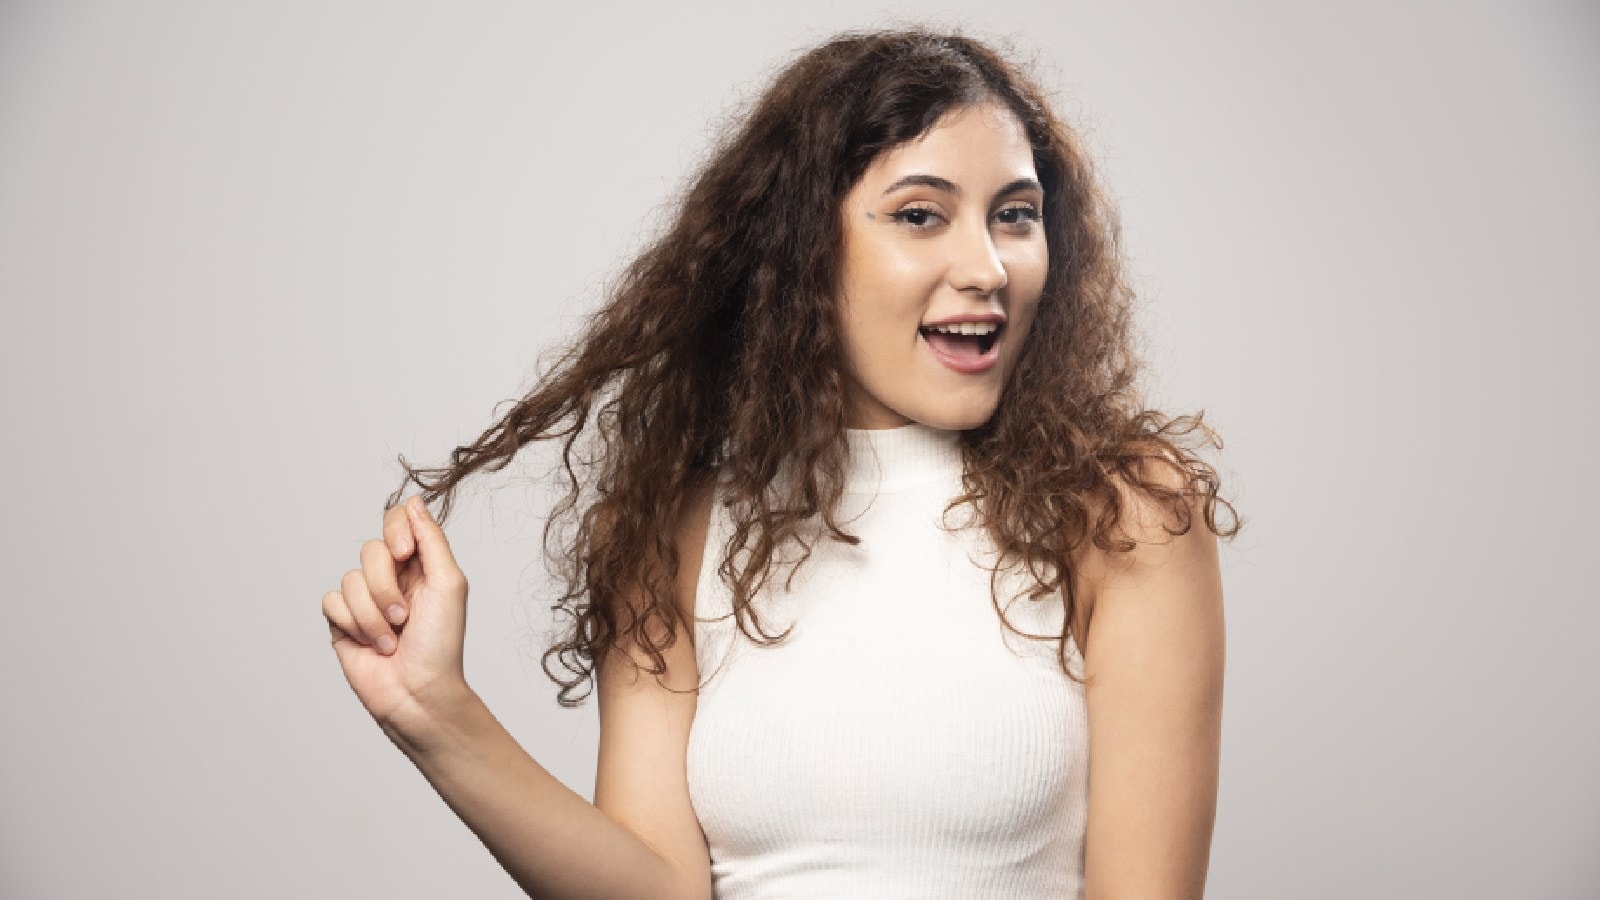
(323, 32, 1237, 897)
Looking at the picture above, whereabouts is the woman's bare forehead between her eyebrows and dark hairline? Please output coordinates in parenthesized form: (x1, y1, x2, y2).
(861, 102, 1037, 186)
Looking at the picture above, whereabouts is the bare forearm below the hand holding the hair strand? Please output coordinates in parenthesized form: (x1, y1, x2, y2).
(384, 690, 683, 898)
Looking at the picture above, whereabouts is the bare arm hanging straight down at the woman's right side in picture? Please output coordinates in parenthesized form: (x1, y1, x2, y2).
(1080, 480, 1224, 900)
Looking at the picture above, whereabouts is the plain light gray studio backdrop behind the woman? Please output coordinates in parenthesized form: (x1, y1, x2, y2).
(0, 0, 1600, 900)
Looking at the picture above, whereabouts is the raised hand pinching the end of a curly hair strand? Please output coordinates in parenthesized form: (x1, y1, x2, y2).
(322, 496, 467, 730)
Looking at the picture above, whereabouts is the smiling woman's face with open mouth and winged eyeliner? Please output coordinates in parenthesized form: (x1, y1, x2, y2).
(840, 102, 1050, 429)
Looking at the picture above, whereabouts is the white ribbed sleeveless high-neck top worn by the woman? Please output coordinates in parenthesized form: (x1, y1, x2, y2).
(688, 424, 1088, 900)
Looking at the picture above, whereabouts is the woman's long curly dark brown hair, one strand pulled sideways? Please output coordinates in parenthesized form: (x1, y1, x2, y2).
(387, 30, 1238, 706)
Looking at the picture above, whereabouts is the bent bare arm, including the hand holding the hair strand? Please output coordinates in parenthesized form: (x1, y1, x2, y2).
(323, 498, 710, 898)
